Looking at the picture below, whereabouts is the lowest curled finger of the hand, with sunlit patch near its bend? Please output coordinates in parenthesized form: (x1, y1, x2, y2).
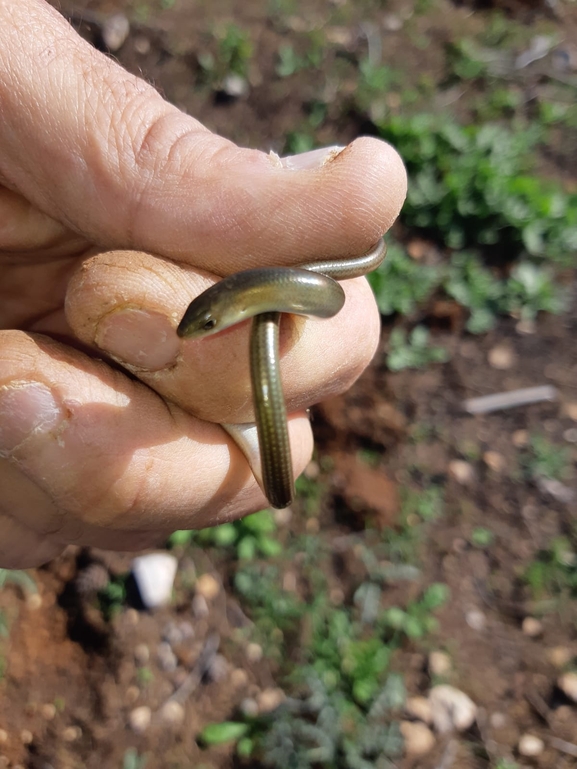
(0, 332, 312, 549)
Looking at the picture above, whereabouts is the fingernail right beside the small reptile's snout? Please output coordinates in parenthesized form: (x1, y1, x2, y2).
(95, 309, 180, 371)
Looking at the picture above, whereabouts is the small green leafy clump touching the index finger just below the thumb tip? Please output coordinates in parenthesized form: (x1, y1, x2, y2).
(368, 242, 441, 315)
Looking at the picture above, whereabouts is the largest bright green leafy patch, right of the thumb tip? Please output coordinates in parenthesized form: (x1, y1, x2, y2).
(379, 115, 577, 264)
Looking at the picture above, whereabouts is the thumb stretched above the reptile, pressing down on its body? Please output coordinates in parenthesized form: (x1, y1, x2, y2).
(0, 0, 406, 275)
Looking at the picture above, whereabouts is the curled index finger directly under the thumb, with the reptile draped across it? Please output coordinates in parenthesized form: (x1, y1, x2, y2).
(66, 251, 380, 423)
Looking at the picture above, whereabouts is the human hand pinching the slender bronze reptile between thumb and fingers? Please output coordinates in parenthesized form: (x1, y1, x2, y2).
(0, 0, 406, 568)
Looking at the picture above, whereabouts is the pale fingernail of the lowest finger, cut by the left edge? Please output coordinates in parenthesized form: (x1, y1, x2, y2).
(0, 382, 64, 456)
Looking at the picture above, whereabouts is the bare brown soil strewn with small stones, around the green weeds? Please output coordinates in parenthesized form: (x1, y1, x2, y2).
(0, 0, 577, 769)
